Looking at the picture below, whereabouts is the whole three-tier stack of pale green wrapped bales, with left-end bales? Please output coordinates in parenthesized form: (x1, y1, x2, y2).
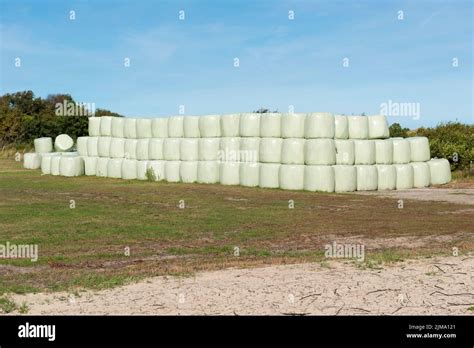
(25, 112, 451, 192)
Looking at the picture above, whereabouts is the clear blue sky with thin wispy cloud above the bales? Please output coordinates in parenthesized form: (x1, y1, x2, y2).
(0, 0, 473, 128)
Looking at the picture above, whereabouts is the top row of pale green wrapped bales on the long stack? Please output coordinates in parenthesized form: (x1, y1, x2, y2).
(89, 112, 389, 139)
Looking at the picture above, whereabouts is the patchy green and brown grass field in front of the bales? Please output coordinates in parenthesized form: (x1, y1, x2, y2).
(0, 159, 474, 294)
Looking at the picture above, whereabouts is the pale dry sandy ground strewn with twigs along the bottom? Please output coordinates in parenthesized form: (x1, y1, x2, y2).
(9, 254, 474, 315)
